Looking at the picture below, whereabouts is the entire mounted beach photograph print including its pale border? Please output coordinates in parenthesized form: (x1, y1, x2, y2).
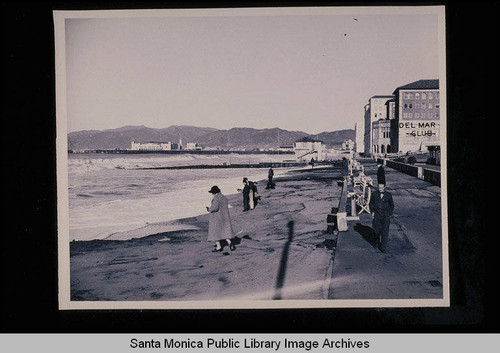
(54, 6, 450, 310)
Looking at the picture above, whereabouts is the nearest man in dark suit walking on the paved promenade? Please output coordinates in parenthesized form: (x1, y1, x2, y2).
(370, 184, 394, 253)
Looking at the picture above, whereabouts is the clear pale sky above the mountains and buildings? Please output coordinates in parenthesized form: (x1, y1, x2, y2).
(64, 10, 440, 134)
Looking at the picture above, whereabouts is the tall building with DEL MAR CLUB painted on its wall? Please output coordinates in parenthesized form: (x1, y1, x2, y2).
(392, 79, 440, 153)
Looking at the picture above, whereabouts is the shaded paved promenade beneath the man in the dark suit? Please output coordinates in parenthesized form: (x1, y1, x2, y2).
(328, 161, 446, 300)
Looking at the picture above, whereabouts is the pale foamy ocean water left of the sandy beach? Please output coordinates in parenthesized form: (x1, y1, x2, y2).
(68, 154, 290, 241)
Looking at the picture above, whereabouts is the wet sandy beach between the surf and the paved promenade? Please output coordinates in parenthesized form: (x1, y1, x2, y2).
(70, 166, 341, 301)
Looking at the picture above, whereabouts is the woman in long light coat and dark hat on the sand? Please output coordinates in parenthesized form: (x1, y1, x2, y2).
(207, 185, 235, 252)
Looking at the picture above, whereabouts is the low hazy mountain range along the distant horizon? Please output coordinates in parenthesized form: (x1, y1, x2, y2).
(68, 125, 355, 150)
